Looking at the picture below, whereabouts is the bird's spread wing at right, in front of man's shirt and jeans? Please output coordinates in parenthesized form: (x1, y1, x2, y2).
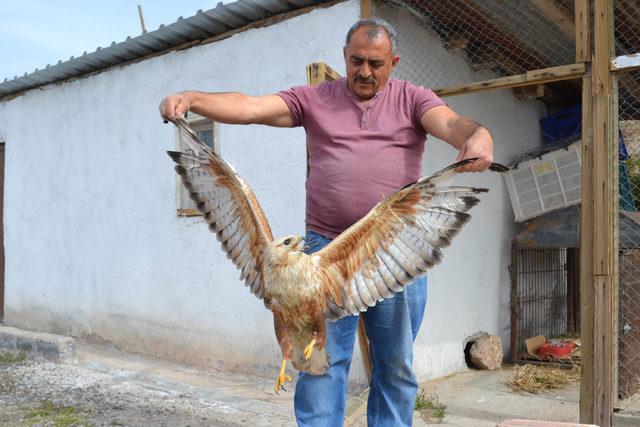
(315, 159, 508, 320)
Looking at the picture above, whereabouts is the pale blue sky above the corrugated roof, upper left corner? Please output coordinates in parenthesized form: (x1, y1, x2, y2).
(0, 0, 230, 83)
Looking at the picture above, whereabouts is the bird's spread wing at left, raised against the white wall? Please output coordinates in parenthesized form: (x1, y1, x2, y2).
(167, 118, 273, 304)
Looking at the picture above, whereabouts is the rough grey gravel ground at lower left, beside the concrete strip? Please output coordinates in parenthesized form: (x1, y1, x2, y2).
(0, 352, 292, 427)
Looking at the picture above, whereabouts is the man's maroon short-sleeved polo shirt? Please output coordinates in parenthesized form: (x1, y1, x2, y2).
(278, 78, 445, 238)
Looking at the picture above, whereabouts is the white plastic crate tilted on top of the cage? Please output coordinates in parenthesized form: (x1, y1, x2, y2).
(502, 141, 582, 222)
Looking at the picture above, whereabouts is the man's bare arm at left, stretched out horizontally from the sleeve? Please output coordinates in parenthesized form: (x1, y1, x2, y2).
(160, 91, 293, 127)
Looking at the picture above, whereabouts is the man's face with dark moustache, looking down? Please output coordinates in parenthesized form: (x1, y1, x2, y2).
(343, 26, 400, 100)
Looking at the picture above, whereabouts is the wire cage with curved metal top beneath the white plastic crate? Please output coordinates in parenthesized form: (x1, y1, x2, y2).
(510, 207, 580, 362)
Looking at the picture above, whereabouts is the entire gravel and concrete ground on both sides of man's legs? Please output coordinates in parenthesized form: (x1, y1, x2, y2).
(0, 344, 640, 427)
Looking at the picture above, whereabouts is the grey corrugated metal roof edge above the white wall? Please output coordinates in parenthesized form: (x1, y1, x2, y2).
(0, 0, 328, 99)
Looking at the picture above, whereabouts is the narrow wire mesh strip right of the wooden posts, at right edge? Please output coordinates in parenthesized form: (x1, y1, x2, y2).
(614, 0, 640, 414)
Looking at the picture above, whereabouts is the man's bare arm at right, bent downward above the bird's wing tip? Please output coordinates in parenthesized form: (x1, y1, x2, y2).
(420, 105, 493, 172)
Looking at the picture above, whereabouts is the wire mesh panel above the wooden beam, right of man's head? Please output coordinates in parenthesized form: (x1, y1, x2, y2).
(373, 0, 575, 88)
